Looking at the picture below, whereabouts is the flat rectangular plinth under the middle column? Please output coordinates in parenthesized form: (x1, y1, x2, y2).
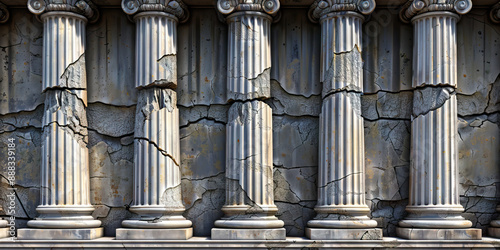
(212, 228, 286, 240)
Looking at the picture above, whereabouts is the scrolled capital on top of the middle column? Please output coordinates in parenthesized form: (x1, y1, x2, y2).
(217, 0, 280, 16)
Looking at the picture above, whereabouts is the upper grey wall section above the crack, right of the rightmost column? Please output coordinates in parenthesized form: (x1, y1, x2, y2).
(457, 9, 500, 116)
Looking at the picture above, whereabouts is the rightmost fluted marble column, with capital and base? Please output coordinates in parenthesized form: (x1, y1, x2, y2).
(396, 0, 481, 240)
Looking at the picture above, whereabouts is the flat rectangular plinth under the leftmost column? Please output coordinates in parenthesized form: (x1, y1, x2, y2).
(17, 227, 104, 240)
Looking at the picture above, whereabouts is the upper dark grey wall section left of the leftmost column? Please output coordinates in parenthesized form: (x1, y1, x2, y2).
(0, 9, 45, 115)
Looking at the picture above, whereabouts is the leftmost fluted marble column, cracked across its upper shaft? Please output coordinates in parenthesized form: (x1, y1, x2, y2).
(18, 0, 103, 239)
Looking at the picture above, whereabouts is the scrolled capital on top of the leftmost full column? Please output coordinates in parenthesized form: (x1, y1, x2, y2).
(28, 0, 99, 23)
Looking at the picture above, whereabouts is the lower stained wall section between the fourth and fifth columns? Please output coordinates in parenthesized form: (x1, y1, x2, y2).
(365, 119, 411, 236)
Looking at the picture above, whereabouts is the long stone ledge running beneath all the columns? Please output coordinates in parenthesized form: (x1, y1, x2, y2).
(0, 237, 500, 249)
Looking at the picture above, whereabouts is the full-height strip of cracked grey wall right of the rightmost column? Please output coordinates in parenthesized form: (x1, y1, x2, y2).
(456, 9, 500, 233)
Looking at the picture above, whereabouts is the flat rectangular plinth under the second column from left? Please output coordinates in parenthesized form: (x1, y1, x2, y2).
(116, 227, 193, 240)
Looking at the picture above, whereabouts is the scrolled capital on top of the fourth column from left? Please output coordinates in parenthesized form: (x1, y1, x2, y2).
(309, 0, 376, 23)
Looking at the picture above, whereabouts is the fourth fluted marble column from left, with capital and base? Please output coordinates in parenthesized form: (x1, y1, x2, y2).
(306, 0, 382, 240)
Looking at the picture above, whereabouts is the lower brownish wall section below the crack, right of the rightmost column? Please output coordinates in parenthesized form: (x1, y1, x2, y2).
(458, 113, 500, 229)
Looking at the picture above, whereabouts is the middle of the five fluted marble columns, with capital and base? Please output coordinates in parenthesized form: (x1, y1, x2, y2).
(212, 0, 286, 240)
